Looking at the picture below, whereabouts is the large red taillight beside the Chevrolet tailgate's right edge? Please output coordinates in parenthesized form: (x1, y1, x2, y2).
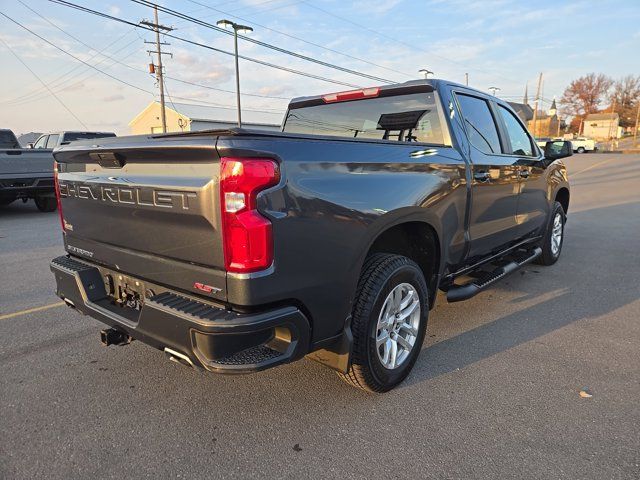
(220, 157, 280, 273)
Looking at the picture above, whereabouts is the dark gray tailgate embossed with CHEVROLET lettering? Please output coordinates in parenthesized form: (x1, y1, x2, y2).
(54, 135, 226, 300)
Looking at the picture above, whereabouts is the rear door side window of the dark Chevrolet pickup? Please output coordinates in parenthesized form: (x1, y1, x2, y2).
(456, 93, 502, 154)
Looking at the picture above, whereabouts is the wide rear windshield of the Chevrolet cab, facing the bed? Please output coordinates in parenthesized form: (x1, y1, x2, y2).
(284, 92, 449, 145)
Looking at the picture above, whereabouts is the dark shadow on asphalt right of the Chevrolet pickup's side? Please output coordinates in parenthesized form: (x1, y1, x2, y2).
(403, 202, 640, 386)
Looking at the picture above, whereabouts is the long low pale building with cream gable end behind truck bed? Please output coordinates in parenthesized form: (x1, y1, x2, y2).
(129, 101, 284, 135)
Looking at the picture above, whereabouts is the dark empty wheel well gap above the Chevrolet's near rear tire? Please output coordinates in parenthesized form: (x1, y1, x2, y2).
(367, 222, 440, 306)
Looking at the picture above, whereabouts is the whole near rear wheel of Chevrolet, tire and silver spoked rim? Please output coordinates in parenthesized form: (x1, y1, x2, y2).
(339, 253, 429, 392)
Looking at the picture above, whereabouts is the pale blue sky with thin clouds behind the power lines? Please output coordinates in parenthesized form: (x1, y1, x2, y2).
(0, 0, 640, 135)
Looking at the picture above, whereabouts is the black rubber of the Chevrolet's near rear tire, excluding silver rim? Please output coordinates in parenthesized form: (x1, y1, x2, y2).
(339, 253, 429, 392)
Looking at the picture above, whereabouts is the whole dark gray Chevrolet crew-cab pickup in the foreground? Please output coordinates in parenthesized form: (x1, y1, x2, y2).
(51, 80, 571, 392)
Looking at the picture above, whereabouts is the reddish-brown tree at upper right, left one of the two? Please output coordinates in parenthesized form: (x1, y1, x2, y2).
(560, 73, 613, 118)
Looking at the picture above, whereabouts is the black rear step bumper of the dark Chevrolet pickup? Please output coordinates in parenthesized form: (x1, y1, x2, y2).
(51, 256, 310, 373)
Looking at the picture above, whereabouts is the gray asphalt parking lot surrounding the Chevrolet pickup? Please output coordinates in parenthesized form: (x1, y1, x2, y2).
(0, 154, 640, 479)
